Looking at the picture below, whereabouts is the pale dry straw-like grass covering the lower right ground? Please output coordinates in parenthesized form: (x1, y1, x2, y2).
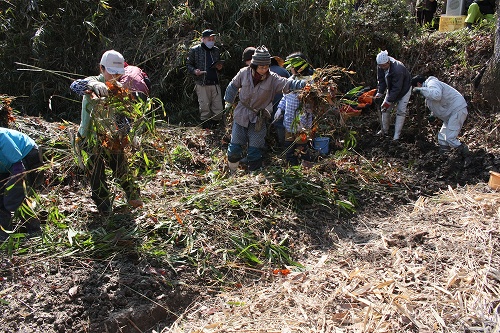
(163, 184, 500, 333)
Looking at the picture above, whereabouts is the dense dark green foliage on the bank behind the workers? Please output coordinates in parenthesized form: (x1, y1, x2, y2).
(0, 0, 416, 123)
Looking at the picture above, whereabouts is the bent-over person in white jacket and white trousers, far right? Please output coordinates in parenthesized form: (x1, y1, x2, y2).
(411, 75, 469, 156)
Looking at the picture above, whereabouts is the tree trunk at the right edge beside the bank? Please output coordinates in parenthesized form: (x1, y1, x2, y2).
(474, 6, 500, 109)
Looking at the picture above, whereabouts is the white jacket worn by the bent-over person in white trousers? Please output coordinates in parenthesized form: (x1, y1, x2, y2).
(420, 76, 467, 121)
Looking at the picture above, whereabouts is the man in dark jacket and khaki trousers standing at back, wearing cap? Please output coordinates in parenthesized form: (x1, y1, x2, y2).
(186, 29, 223, 129)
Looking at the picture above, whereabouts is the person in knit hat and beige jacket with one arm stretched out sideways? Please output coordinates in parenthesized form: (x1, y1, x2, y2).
(224, 46, 305, 172)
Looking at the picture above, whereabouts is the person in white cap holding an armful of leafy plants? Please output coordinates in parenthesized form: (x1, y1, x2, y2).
(70, 50, 149, 215)
